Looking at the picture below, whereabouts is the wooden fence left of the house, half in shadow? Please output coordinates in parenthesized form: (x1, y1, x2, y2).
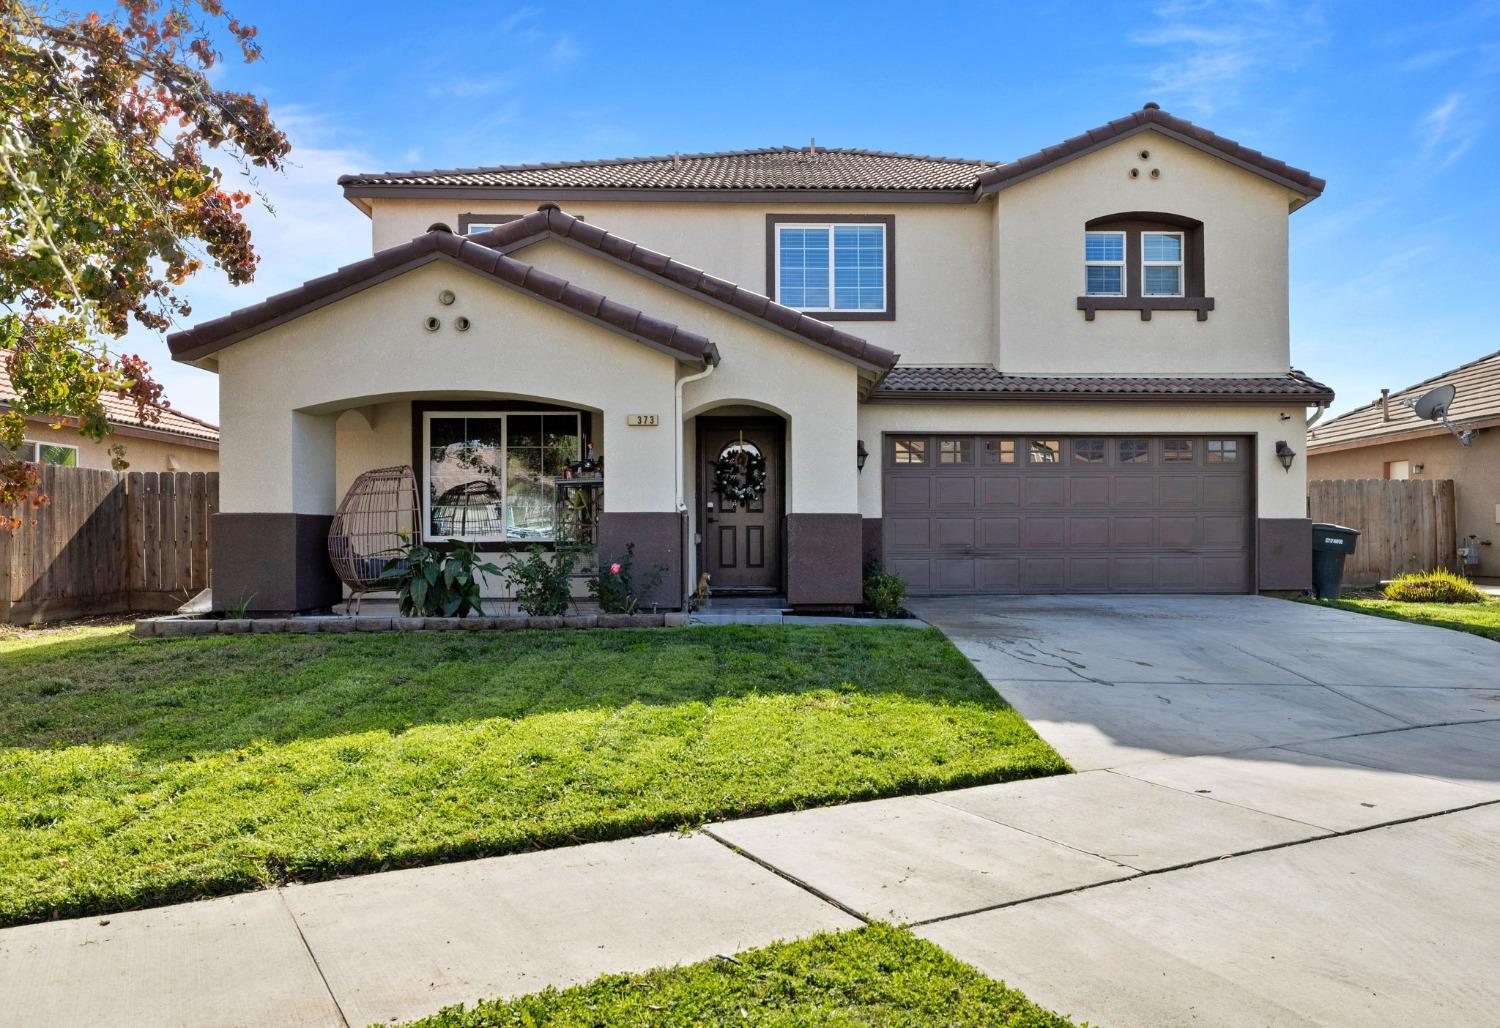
(0, 467, 219, 624)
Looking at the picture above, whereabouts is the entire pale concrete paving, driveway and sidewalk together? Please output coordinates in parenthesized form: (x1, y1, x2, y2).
(0, 597, 1500, 1026)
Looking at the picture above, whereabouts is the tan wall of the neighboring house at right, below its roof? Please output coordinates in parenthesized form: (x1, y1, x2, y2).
(1308, 429, 1500, 576)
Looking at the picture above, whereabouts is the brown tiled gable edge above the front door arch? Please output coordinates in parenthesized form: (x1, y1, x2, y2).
(468, 203, 900, 372)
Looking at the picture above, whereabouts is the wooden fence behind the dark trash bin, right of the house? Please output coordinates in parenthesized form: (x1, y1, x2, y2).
(1308, 479, 1458, 587)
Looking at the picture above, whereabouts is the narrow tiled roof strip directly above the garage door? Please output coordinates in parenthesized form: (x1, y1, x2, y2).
(870, 365, 1334, 404)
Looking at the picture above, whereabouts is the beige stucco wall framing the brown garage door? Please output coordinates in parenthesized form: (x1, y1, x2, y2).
(860, 404, 1307, 518)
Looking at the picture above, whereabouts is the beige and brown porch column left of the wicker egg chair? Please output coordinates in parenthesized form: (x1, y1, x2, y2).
(212, 408, 342, 615)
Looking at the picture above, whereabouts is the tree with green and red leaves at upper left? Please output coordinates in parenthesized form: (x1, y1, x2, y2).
(0, 0, 291, 530)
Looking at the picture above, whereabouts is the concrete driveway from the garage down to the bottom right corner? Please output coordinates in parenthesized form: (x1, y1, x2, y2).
(894, 597, 1500, 1025)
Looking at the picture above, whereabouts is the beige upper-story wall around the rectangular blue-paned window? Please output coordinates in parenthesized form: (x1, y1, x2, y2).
(369, 195, 996, 365)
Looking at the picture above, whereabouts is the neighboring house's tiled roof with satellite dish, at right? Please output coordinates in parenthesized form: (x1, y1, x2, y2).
(1308, 351, 1500, 453)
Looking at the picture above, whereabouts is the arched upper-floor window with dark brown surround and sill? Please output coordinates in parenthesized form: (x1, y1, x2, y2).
(1079, 212, 1214, 321)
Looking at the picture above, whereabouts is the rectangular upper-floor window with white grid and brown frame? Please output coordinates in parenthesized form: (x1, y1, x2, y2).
(767, 215, 896, 321)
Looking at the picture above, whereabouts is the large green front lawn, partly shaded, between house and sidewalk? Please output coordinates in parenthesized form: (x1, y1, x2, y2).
(0, 626, 1068, 924)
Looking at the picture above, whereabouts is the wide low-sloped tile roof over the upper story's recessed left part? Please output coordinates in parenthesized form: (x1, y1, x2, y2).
(339, 147, 996, 192)
